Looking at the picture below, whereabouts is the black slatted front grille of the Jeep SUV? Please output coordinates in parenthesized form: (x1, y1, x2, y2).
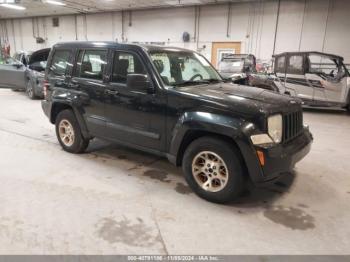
(282, 111, 303, 142)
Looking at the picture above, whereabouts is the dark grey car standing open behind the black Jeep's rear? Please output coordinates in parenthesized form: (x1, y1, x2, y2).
(0, 48, 50, 99)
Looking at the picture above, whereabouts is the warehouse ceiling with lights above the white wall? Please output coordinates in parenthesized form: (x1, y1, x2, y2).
(0, 0, 260, 19)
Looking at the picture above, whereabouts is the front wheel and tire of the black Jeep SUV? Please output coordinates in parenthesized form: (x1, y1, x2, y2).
(182, 137, 244, 203)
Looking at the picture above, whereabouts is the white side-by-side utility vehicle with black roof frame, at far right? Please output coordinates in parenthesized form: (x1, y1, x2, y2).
(269, 52, 350, 110)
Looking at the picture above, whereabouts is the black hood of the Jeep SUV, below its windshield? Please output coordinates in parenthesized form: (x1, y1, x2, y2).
(177, 83, 301, 114)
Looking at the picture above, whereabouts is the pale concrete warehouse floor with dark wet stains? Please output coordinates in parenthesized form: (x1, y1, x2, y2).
(0, 89, 350, 254)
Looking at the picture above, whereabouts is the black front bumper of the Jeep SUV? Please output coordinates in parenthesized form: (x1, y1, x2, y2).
(246, 128, 313, 184)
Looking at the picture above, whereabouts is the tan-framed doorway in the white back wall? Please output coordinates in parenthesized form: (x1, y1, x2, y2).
(211, 42, 241, 69)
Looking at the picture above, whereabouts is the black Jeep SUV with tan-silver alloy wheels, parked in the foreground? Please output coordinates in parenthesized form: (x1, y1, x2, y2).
(42, 42, 312, 203)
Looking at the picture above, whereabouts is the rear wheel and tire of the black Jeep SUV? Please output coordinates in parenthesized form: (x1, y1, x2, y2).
(55, 109, 89, 154)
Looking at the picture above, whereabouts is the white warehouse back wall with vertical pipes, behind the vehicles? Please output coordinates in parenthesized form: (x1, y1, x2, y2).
(0, 0, 350, 62)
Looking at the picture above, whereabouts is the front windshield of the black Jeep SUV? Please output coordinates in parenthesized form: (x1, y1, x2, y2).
(150, 50, 222, 86)
